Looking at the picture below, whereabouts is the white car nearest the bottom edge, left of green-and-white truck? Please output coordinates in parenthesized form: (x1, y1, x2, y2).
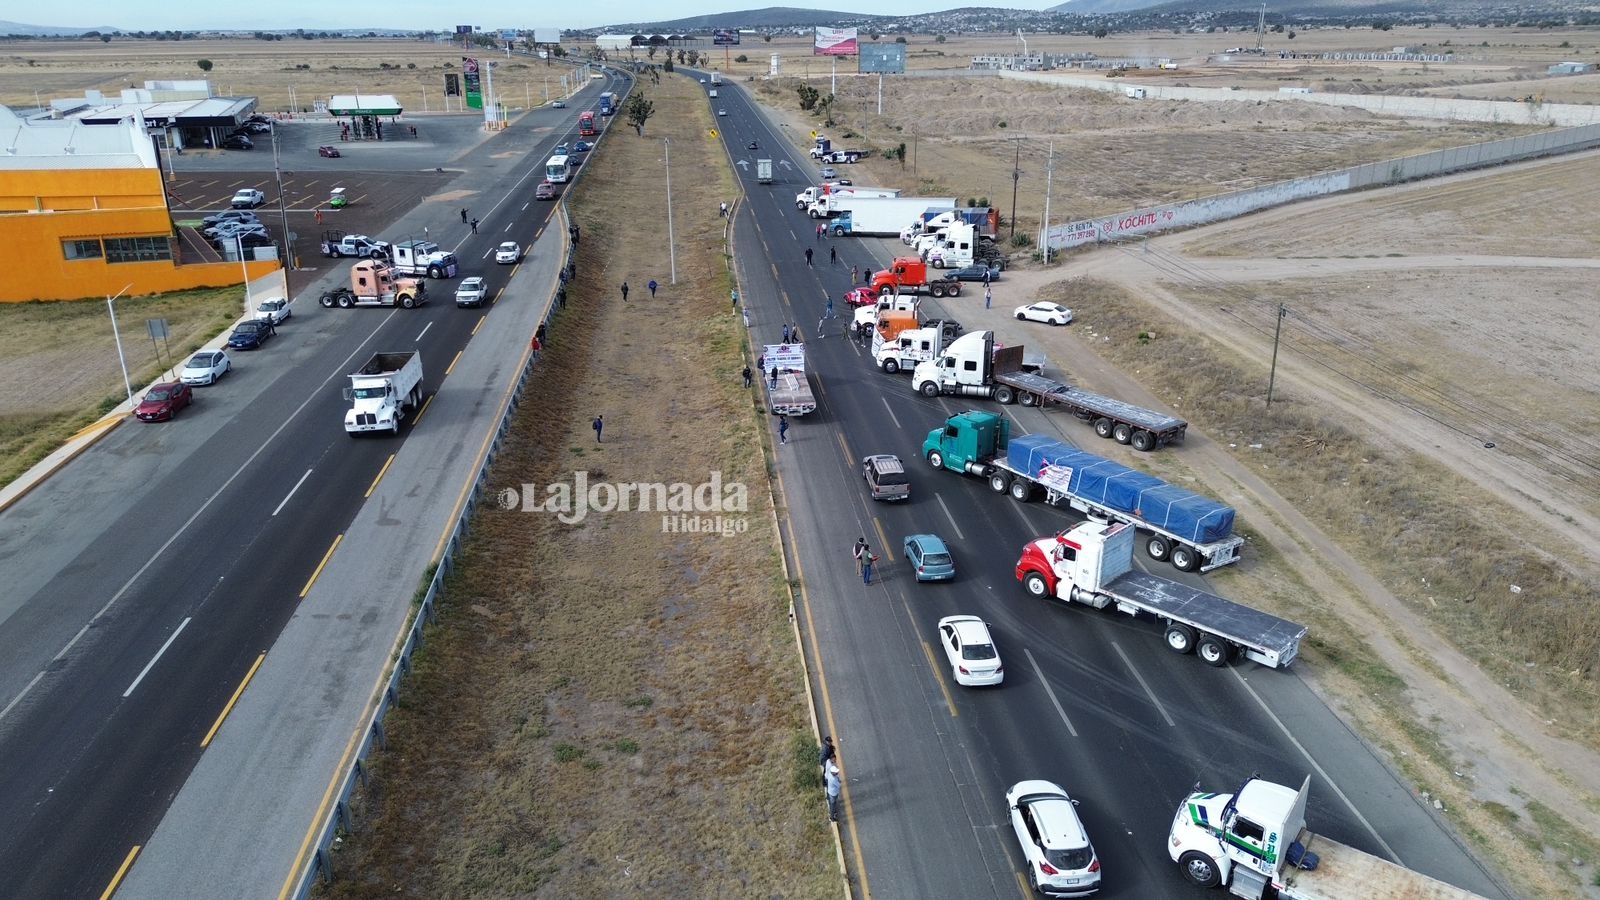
(1005, 781, 1101, 897)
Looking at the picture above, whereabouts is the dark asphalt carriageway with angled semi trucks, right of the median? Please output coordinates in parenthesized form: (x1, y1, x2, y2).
(710, 71, 1504, 898)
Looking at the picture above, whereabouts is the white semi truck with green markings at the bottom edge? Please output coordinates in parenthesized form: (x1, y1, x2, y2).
(1166, 775, 1482, 900)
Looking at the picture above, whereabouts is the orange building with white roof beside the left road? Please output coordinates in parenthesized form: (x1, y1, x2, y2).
(0, 106, 280, 303)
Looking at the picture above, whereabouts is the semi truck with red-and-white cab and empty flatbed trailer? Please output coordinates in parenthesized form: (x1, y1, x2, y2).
(1016, 520, 1305, 666)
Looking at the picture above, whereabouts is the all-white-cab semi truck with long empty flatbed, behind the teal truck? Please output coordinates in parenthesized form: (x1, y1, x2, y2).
(912, 331, 1189, 453)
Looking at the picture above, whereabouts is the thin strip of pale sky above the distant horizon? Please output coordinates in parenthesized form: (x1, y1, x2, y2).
(43, 0, 1058, 30)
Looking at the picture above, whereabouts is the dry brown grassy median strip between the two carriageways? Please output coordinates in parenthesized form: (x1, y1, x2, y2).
(316, 75, 840, 897)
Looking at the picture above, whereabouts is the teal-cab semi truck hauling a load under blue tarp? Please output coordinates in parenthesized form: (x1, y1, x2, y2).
(922, 408, 1245, 572)
